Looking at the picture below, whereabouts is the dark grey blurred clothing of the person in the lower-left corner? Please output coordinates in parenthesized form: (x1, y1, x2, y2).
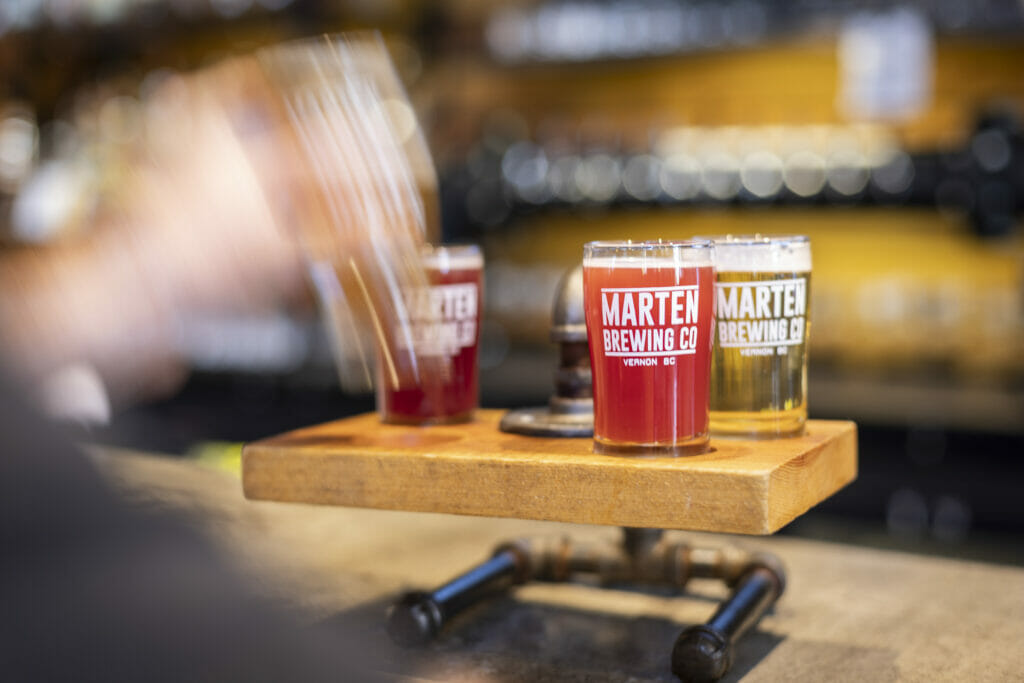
(0, 366, 393, 683)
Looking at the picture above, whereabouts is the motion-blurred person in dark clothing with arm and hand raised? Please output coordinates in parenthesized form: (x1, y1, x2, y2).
(0, 38, 436, 681)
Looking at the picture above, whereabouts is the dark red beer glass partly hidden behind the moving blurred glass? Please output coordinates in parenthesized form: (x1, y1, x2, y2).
(377, 245, 483, 424)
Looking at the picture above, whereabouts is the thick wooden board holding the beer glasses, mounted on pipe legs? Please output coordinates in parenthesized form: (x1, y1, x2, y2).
(242, 411, 857, 533)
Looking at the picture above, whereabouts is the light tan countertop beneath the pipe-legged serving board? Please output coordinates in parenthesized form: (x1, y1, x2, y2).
(97, 452, 1024, 682)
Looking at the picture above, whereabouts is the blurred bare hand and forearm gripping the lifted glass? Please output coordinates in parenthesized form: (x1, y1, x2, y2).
(0, 58, 304, 402)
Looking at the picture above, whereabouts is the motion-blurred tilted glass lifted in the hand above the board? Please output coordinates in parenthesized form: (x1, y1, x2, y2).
(256, 33, 443, 391)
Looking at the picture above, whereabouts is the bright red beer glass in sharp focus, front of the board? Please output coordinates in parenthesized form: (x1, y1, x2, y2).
(583, 241, 715, 455)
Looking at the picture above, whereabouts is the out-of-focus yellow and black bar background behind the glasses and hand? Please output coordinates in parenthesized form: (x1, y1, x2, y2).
(0, 0, 1024, 564)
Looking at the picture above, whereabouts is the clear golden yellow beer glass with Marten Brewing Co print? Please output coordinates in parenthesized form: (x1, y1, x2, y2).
(711, 236, 811, 438)
